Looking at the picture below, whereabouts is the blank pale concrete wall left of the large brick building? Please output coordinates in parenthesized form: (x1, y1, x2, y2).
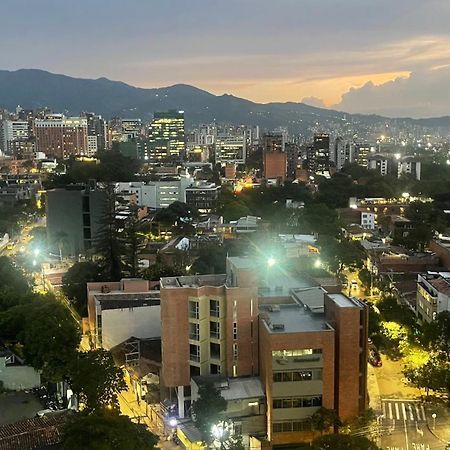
(102, 305, 161, 350)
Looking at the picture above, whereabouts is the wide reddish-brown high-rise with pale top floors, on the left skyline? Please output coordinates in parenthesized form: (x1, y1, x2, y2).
(34, 114, 88, 159)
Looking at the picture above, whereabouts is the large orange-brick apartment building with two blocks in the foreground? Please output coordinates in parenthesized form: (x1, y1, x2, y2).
(161, 257, 367, 444)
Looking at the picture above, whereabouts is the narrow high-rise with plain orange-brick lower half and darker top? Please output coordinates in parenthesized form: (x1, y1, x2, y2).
(262, 132, 287, 183)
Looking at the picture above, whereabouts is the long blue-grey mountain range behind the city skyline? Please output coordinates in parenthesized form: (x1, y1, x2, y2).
(0, 69, 450, 132)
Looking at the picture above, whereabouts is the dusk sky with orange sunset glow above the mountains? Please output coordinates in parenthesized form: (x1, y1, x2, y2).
(0, 0, 450, 117)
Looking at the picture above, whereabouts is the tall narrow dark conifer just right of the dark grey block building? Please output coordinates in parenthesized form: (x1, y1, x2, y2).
(94, 184, 123, 281)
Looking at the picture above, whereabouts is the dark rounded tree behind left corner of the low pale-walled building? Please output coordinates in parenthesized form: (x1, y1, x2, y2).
(62, 261, 102, 317)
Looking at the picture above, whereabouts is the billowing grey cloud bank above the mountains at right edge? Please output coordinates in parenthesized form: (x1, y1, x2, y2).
(333, 65, 450, 117)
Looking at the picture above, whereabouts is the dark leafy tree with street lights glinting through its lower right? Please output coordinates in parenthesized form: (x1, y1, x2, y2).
(69, 349, 127, 413)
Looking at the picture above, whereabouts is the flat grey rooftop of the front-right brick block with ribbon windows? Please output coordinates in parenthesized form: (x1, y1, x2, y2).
(260, 305, 332, 334)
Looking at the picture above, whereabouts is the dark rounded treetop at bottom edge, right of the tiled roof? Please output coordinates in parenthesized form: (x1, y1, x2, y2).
(62, 411, 158, 450)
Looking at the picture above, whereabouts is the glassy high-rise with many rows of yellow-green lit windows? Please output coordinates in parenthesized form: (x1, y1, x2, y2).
(149, 110, 186, 160)
